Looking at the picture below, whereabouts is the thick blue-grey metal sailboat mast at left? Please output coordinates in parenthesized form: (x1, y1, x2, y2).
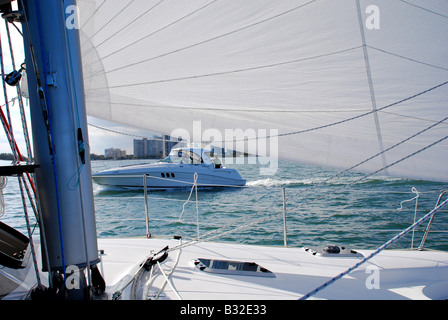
(18, 0, 99, 296)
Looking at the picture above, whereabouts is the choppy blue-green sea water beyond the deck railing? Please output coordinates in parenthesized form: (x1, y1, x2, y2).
(0, 158, 448, 250)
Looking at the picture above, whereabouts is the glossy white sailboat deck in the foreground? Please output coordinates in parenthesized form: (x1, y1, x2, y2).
(99, 238, 448, 300)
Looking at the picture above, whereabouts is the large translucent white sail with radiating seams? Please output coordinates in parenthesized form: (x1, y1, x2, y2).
(78, 0, 448, 181)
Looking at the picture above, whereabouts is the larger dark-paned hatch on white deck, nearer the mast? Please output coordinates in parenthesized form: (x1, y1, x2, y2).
(193, 258, 275, 278)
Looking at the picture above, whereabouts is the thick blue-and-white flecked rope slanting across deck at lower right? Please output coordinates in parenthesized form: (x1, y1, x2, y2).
(299, 195, 448, 300)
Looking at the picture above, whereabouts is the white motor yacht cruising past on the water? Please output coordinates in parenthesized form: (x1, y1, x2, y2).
(93, 147, 246, 190)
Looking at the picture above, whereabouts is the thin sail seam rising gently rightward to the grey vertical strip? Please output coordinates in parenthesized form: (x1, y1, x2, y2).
(105, 46, 363, 88)
